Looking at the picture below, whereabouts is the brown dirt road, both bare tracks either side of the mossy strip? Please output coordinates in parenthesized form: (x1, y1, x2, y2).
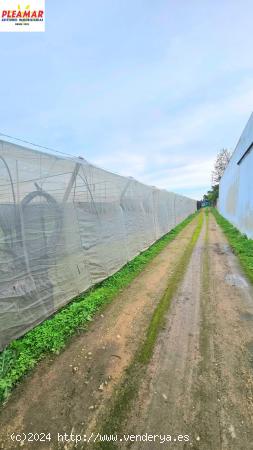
(0, 212, 253, 450)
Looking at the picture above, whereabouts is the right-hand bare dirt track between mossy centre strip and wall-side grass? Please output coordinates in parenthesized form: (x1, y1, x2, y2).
(123, 216, 253, 450)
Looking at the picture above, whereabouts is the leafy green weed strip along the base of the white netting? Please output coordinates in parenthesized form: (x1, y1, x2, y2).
(0, 213, 197, 402)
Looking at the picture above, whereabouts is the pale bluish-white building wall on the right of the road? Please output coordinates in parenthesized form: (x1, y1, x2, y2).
(218, 114, 253, 238)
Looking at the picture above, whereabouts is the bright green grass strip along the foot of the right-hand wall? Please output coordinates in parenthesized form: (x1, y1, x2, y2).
(212, 208, 253, 283)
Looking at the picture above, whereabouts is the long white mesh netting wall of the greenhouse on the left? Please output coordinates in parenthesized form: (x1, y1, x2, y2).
(0, 141, 196, 350)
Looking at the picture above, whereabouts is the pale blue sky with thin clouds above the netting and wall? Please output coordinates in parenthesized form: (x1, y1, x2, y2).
(0, 0, 253, 198)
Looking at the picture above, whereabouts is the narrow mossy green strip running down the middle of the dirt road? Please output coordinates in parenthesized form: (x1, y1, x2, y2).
(97, 214, 203, 449)
